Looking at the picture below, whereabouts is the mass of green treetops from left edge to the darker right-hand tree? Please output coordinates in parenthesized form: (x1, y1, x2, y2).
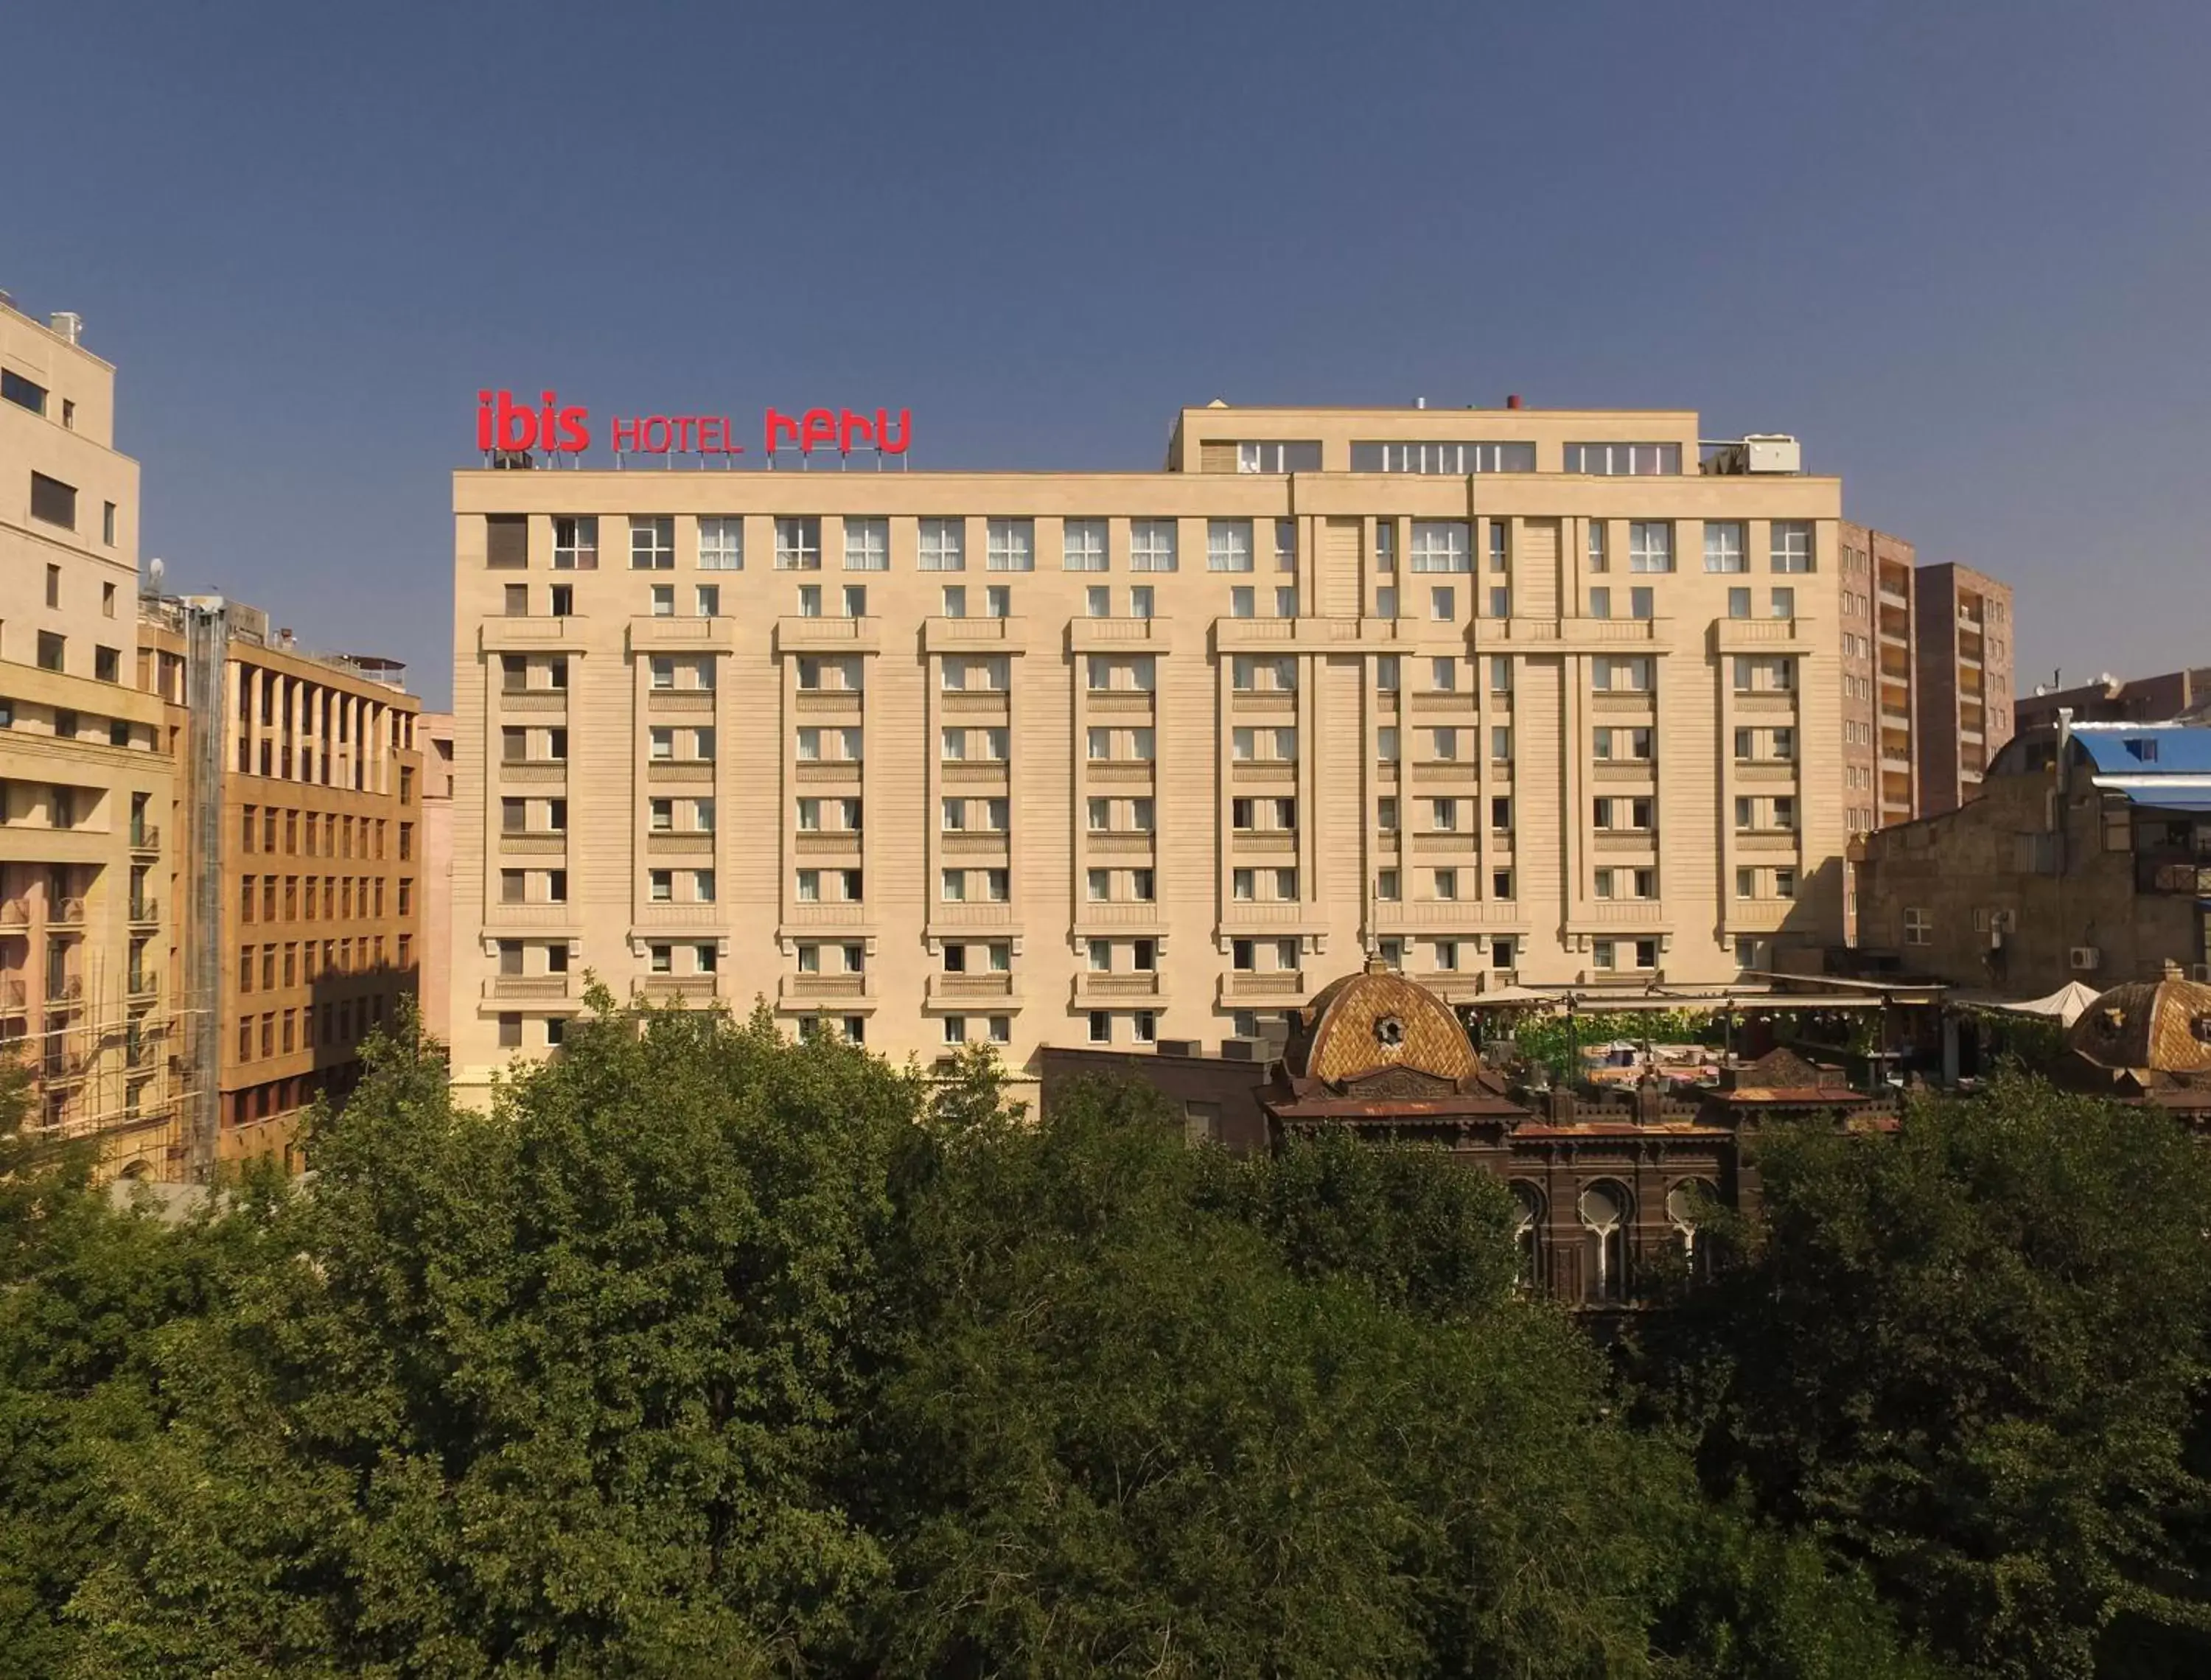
(0, 993, 1990, 1680)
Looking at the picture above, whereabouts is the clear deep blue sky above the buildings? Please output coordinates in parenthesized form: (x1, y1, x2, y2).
(0, 0, 2211, 703)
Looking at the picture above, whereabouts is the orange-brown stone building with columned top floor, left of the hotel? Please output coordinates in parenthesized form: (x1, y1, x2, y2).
(142, 597, 422, 1161)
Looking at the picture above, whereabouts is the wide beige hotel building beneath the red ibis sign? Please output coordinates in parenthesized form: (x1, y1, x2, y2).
(451, 405, 1846, 1088)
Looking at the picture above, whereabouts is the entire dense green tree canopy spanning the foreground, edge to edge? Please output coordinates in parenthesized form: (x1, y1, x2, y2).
(21, 997, 2211, 1680)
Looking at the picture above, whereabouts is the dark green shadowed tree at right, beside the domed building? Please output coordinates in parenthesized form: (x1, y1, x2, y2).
(1663, 1077, 2211, 1678)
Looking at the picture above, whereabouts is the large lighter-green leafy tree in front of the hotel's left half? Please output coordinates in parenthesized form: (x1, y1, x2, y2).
(77, 993, 920, 1676)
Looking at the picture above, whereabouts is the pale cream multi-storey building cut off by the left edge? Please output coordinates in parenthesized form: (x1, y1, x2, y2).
(0, 296, 177, 1174)
